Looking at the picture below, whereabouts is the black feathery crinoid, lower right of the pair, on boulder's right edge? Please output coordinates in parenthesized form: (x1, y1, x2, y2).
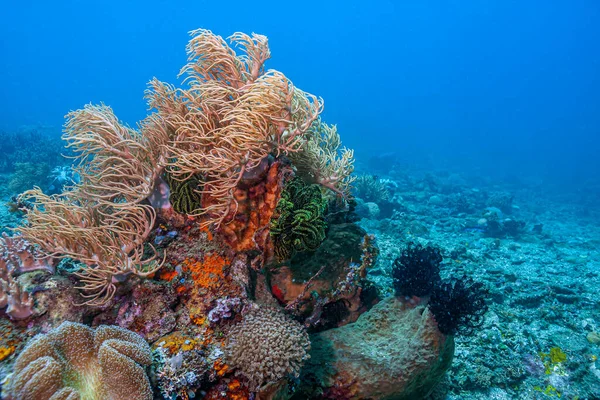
(429, 275, 488, 335)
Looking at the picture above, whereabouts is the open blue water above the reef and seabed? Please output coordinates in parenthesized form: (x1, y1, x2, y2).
(0, 0, 600, 188)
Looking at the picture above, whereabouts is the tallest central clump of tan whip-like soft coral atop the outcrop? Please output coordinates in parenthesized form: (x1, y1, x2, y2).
(147, 29, 323, 225)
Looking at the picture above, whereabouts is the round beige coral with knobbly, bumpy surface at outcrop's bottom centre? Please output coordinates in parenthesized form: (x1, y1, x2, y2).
(227, 306, 310, 390)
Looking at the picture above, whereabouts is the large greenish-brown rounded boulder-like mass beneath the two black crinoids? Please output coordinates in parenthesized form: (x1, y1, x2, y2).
(297, 297, 454, 400)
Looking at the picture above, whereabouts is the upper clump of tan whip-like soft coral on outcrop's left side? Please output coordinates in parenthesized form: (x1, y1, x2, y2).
(63, 105, 168, 206)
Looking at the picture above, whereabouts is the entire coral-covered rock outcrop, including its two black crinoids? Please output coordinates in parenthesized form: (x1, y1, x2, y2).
(0, 30, 486, 400)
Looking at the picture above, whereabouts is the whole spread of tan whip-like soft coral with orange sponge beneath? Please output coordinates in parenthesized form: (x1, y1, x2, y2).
(15, 29, 353, 305)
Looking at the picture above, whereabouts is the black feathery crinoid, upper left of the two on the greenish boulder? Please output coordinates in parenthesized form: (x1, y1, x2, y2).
(392, 243, 442, 297)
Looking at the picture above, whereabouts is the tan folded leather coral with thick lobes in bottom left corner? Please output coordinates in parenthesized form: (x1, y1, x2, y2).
(8, 322, 152, 400)
